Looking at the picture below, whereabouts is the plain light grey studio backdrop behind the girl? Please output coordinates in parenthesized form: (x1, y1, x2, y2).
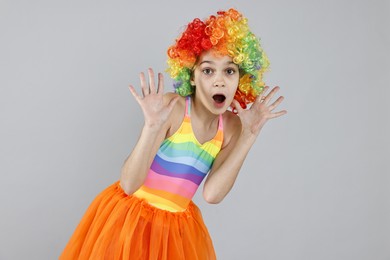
(0, 0, 390, 260)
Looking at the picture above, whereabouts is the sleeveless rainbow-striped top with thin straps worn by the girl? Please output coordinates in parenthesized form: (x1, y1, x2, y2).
(134, 97, 223, 212)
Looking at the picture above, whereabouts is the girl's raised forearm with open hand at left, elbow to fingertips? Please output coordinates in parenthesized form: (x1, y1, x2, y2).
(120, 69, 178, 194)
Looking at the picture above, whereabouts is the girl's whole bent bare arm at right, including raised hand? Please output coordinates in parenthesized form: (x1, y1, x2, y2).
(203, 87, 287, 203)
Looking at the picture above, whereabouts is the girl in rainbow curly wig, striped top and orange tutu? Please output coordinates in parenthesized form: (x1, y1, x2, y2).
(61, 9, 286, 260)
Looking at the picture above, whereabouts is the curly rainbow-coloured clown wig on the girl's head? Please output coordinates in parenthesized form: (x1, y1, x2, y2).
(167, 9, 269, 108)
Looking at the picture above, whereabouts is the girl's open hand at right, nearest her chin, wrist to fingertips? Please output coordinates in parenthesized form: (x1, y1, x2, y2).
(233, 86, 287, 136)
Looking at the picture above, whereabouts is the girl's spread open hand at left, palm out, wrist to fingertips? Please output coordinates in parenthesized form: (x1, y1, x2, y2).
(129, 68, 179, 129)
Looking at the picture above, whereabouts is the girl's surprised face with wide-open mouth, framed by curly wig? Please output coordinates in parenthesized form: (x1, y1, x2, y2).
(191, 51, 240, 114)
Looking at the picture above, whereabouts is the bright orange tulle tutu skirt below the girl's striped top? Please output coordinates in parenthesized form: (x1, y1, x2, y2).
(60, 182, 216, 260)
